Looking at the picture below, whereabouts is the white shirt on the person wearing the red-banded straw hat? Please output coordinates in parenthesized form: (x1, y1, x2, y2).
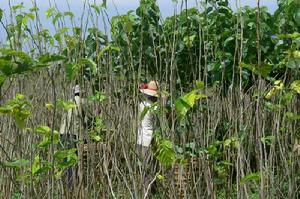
(137, 100, 156, 147)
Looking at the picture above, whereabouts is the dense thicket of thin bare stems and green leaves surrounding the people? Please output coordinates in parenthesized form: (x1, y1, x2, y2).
(0, 0, 300, 199)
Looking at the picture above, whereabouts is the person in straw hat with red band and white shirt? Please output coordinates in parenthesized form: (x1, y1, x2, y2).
(137, 81, 159, 194)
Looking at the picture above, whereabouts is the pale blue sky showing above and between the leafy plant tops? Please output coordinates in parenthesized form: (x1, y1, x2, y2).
(0, 0, 277, 42)
